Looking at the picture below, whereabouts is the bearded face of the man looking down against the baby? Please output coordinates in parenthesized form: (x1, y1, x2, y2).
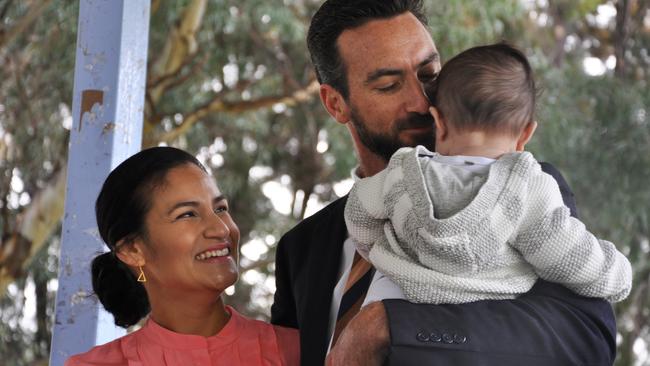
(338, 13, 440, 161)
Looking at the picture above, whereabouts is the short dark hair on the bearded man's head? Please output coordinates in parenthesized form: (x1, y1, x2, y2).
(307, 0, 427, 99)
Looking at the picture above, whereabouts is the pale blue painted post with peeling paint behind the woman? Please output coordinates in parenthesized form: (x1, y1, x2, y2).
(50, 0, 150, 366)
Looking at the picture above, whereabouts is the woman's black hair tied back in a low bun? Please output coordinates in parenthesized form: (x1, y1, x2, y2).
(91, 147, 205, 328)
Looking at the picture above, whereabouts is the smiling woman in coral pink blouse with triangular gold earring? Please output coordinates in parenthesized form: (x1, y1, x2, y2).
(66, 147, 299, 366)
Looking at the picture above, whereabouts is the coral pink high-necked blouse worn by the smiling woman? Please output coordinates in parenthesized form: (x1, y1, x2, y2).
(65, 306, 300, 366)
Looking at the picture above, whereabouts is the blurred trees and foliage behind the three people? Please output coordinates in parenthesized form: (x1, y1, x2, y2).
(0, 0, 650, 366)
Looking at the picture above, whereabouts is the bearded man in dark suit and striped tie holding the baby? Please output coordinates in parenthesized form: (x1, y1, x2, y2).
(271, 0, 616, 366)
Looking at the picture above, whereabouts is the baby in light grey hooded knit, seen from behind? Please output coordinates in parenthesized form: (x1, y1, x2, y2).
(345, 43, 632, 304)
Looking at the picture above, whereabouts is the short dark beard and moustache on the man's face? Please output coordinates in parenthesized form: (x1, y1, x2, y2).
(350, 107, 436, 162)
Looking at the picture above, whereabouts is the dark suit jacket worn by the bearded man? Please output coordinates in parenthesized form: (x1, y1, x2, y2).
(271, 163, 616, 366)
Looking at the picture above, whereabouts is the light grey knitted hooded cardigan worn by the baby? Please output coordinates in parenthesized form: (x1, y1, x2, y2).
(345, 146, 632, 304)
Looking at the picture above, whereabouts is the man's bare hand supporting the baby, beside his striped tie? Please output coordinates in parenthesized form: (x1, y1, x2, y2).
(326, 301, 390, 366)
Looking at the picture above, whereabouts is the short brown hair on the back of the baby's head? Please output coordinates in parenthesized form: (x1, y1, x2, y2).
(427, 43, 537, 135)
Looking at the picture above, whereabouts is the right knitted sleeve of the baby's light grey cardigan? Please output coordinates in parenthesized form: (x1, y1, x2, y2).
(512, 172, 632, 302)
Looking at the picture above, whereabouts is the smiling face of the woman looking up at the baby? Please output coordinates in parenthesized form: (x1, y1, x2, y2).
(141, 164, 239, 294)
